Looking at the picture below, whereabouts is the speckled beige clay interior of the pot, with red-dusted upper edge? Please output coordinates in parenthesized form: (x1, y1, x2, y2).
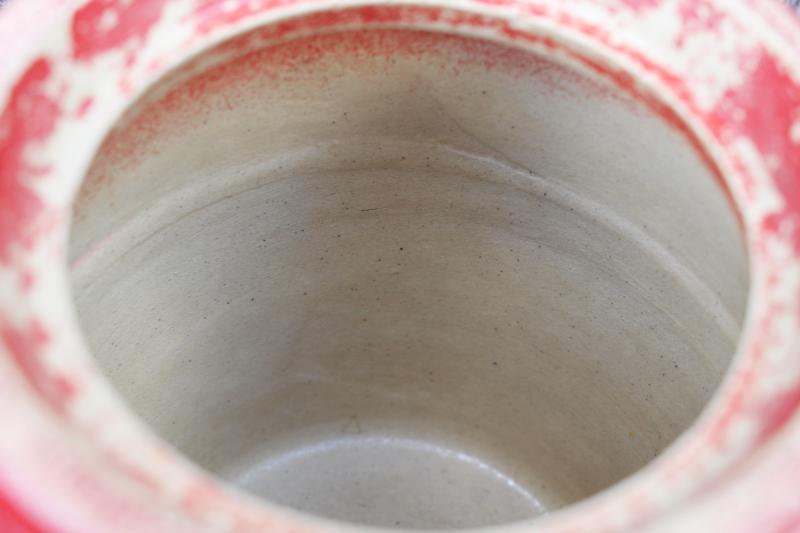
(71, 30, 747, 528)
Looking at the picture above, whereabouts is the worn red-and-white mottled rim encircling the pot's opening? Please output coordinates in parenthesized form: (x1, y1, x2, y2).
(0, 0, 800, 531)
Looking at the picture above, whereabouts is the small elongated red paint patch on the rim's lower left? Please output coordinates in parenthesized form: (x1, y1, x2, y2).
(0, 322, 76, 410)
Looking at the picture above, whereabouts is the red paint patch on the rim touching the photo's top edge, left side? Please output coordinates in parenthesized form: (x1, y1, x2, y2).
(72, 0, 169, 61)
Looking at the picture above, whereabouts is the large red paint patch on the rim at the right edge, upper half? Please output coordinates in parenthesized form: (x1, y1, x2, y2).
(708, 54, 800, 255)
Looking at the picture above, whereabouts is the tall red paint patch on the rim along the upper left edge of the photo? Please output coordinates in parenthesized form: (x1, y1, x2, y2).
(0, 58, 61, 263)
